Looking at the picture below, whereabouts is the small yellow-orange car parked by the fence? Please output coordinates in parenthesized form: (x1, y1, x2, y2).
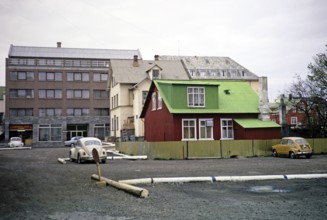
(272, 137, 313, 159)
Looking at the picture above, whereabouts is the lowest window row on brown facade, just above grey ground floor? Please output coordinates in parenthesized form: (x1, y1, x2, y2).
(9, 108, 109, 117)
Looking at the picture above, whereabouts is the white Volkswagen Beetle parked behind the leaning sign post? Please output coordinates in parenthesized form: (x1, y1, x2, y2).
(69, 137, 107, 163)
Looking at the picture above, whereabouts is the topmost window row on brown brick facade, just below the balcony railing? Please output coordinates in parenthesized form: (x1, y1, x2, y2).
(10, 71, 108, 82)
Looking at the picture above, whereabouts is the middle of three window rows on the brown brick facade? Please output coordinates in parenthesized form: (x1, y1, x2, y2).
(9, 89, 109, 99)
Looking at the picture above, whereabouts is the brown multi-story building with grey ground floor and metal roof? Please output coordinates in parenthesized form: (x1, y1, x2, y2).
(5, 42, 141, 146)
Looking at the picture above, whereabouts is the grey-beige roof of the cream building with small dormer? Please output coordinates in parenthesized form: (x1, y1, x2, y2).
(111, 60, 189, 84)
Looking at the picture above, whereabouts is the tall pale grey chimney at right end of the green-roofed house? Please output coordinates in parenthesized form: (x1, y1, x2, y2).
(259, 77, 270, 121)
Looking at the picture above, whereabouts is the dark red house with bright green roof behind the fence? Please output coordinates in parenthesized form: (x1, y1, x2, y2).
(140, 80, 280, 142)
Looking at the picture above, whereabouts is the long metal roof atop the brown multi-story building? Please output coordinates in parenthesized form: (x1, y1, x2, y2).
(8, 45, 142, 59)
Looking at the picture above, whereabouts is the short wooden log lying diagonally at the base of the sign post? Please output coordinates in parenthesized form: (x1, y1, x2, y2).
(91, 174, 149, 198)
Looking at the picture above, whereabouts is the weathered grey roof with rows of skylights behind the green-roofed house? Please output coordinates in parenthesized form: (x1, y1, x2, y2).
(159, 55, 258, 79)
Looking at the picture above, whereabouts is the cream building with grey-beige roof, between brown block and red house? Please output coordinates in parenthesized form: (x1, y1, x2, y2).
(108, 56, 189, 141)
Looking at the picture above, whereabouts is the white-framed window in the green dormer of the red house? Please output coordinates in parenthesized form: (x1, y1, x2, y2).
(187, 87, 205, 108)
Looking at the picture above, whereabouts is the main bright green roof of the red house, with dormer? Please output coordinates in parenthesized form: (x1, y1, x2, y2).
(154, 80, 259, 114)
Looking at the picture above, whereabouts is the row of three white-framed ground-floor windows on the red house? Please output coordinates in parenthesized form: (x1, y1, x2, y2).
(182, 118, 234, 140)
